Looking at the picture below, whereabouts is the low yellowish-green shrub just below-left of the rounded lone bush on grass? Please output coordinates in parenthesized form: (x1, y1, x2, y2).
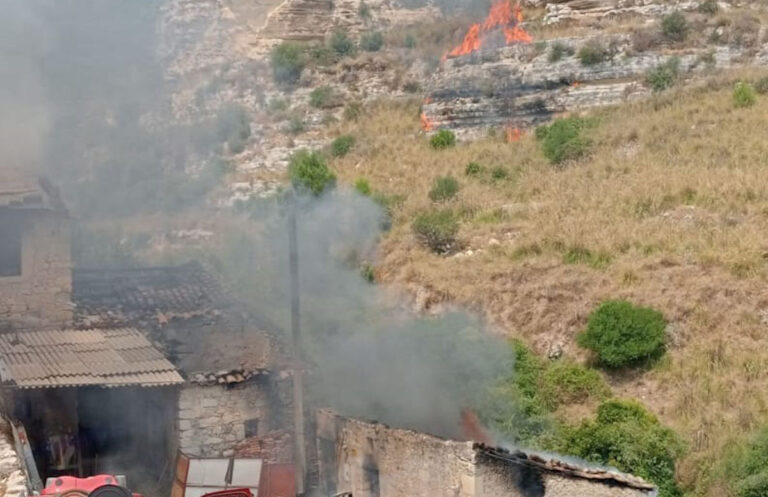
(541, 360, 611, 409)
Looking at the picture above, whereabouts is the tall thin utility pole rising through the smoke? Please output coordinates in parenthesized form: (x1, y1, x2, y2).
(288, 192, 307, 497)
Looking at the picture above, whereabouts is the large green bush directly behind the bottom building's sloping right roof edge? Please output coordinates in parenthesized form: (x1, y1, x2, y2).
(557, 400, 684, 497)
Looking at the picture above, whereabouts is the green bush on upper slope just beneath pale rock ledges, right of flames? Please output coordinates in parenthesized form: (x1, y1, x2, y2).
(536, 117, 592, 165)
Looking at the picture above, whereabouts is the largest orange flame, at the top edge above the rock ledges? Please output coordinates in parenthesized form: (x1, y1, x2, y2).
(443, 0, 533, 59)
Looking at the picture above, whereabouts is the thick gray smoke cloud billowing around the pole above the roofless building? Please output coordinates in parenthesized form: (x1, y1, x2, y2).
(223, 190, 512, 437)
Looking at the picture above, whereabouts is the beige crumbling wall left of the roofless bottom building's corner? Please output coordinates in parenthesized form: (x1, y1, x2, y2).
(317, 411, 475, 497)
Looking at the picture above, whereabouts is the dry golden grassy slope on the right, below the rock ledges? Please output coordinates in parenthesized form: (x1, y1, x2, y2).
(333, 71, 768, 495)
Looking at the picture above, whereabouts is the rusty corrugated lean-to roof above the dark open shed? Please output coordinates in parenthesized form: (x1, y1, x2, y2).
(0, 328, 184, 388)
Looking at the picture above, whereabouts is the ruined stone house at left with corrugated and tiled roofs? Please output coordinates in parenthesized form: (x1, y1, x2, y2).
(0, 178, 290, 488)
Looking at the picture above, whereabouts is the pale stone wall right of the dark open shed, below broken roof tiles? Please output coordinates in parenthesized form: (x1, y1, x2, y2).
(177, 381, 272, 457)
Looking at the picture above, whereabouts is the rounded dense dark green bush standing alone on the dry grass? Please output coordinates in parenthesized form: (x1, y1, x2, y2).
(577, 300, 666, 368)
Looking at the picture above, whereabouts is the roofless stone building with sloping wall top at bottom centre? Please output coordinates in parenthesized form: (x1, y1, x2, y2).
(316, 410, 656, 497)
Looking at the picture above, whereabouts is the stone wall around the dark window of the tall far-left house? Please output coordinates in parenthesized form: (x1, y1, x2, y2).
(0, 211, 72, 327)
